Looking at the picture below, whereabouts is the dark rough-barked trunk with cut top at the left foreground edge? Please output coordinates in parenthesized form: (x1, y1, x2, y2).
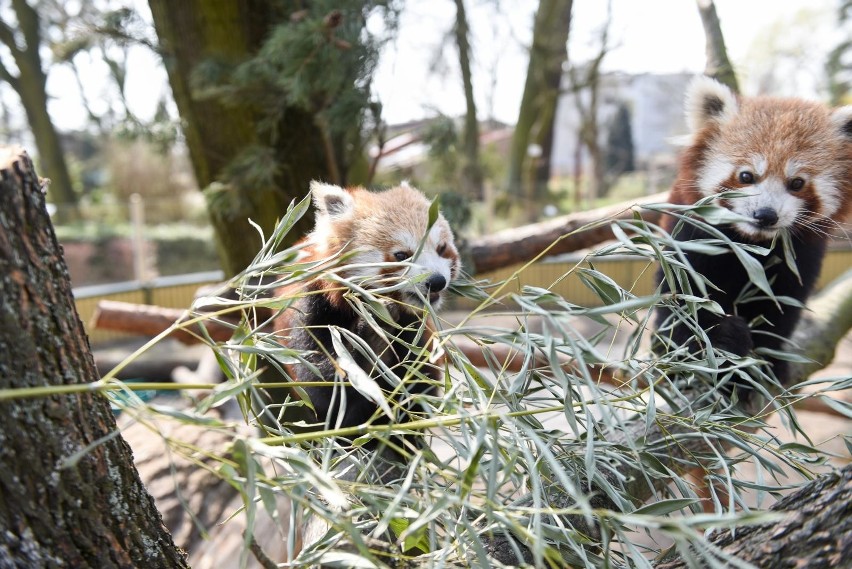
(0, 150, 187, 568)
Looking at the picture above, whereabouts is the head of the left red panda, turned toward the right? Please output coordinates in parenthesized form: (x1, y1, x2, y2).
(308, 182, 459, 309)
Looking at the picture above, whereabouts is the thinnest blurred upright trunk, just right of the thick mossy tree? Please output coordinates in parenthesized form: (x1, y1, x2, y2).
(455, 0, 482, 199)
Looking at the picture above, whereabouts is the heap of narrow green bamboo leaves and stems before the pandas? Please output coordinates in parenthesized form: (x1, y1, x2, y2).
(95, 193, 849, 567)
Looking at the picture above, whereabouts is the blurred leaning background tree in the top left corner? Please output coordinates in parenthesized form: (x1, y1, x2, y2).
(0, 0, 78, 219)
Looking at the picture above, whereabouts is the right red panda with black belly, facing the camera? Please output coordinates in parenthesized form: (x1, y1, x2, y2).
(655, 77, 852, 390)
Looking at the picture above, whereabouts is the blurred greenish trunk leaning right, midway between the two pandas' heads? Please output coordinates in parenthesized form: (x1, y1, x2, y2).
(508, 0, 573, 212)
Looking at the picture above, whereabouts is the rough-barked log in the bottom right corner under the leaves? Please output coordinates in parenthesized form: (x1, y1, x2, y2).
(656, 465, 852, 569)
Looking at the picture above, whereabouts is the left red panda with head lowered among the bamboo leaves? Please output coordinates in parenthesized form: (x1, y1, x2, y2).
(273, 182, 460, 428)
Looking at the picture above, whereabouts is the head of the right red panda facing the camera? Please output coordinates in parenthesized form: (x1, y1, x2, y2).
(687, 78, 852, 239)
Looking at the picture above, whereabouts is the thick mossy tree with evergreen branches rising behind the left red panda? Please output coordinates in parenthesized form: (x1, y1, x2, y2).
(149, 0, 395, 274)
